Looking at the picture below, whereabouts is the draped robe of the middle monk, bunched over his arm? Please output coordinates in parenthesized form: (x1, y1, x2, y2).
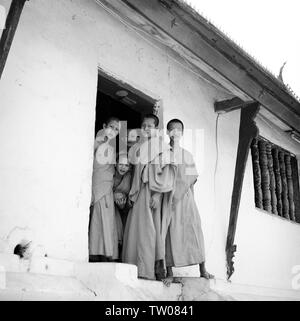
(122, 142, 176, 279)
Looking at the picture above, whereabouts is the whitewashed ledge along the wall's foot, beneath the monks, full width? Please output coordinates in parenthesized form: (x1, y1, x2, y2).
(0, 253, 300, 301)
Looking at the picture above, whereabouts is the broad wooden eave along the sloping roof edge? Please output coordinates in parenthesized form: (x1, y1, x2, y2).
(122, 0, 300, 131)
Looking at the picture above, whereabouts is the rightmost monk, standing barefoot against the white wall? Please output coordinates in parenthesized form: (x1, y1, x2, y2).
(162, 119, 213, 286)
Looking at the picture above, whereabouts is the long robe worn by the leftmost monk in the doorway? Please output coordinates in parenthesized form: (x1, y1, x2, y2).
(89, 131, 118, 259)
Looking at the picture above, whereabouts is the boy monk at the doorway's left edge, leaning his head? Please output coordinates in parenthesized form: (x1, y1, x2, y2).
(89, 117, 120, 262)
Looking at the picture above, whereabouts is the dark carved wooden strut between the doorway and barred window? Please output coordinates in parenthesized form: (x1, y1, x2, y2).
(226, 102, 259, 279)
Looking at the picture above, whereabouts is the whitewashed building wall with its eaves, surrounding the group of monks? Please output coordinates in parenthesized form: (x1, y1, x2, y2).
(0, 0, 300, 299)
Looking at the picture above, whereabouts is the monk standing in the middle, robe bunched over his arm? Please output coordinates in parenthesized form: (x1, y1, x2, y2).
(122, 114, 176, 280)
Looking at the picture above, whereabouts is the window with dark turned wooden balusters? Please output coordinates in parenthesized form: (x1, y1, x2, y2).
(251, 137, 300, 223)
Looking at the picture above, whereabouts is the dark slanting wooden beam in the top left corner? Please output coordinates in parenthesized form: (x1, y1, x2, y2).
(0, 0, 28, 79)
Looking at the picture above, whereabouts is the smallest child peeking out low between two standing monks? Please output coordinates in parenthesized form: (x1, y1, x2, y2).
(113, 153, 131, 255)
